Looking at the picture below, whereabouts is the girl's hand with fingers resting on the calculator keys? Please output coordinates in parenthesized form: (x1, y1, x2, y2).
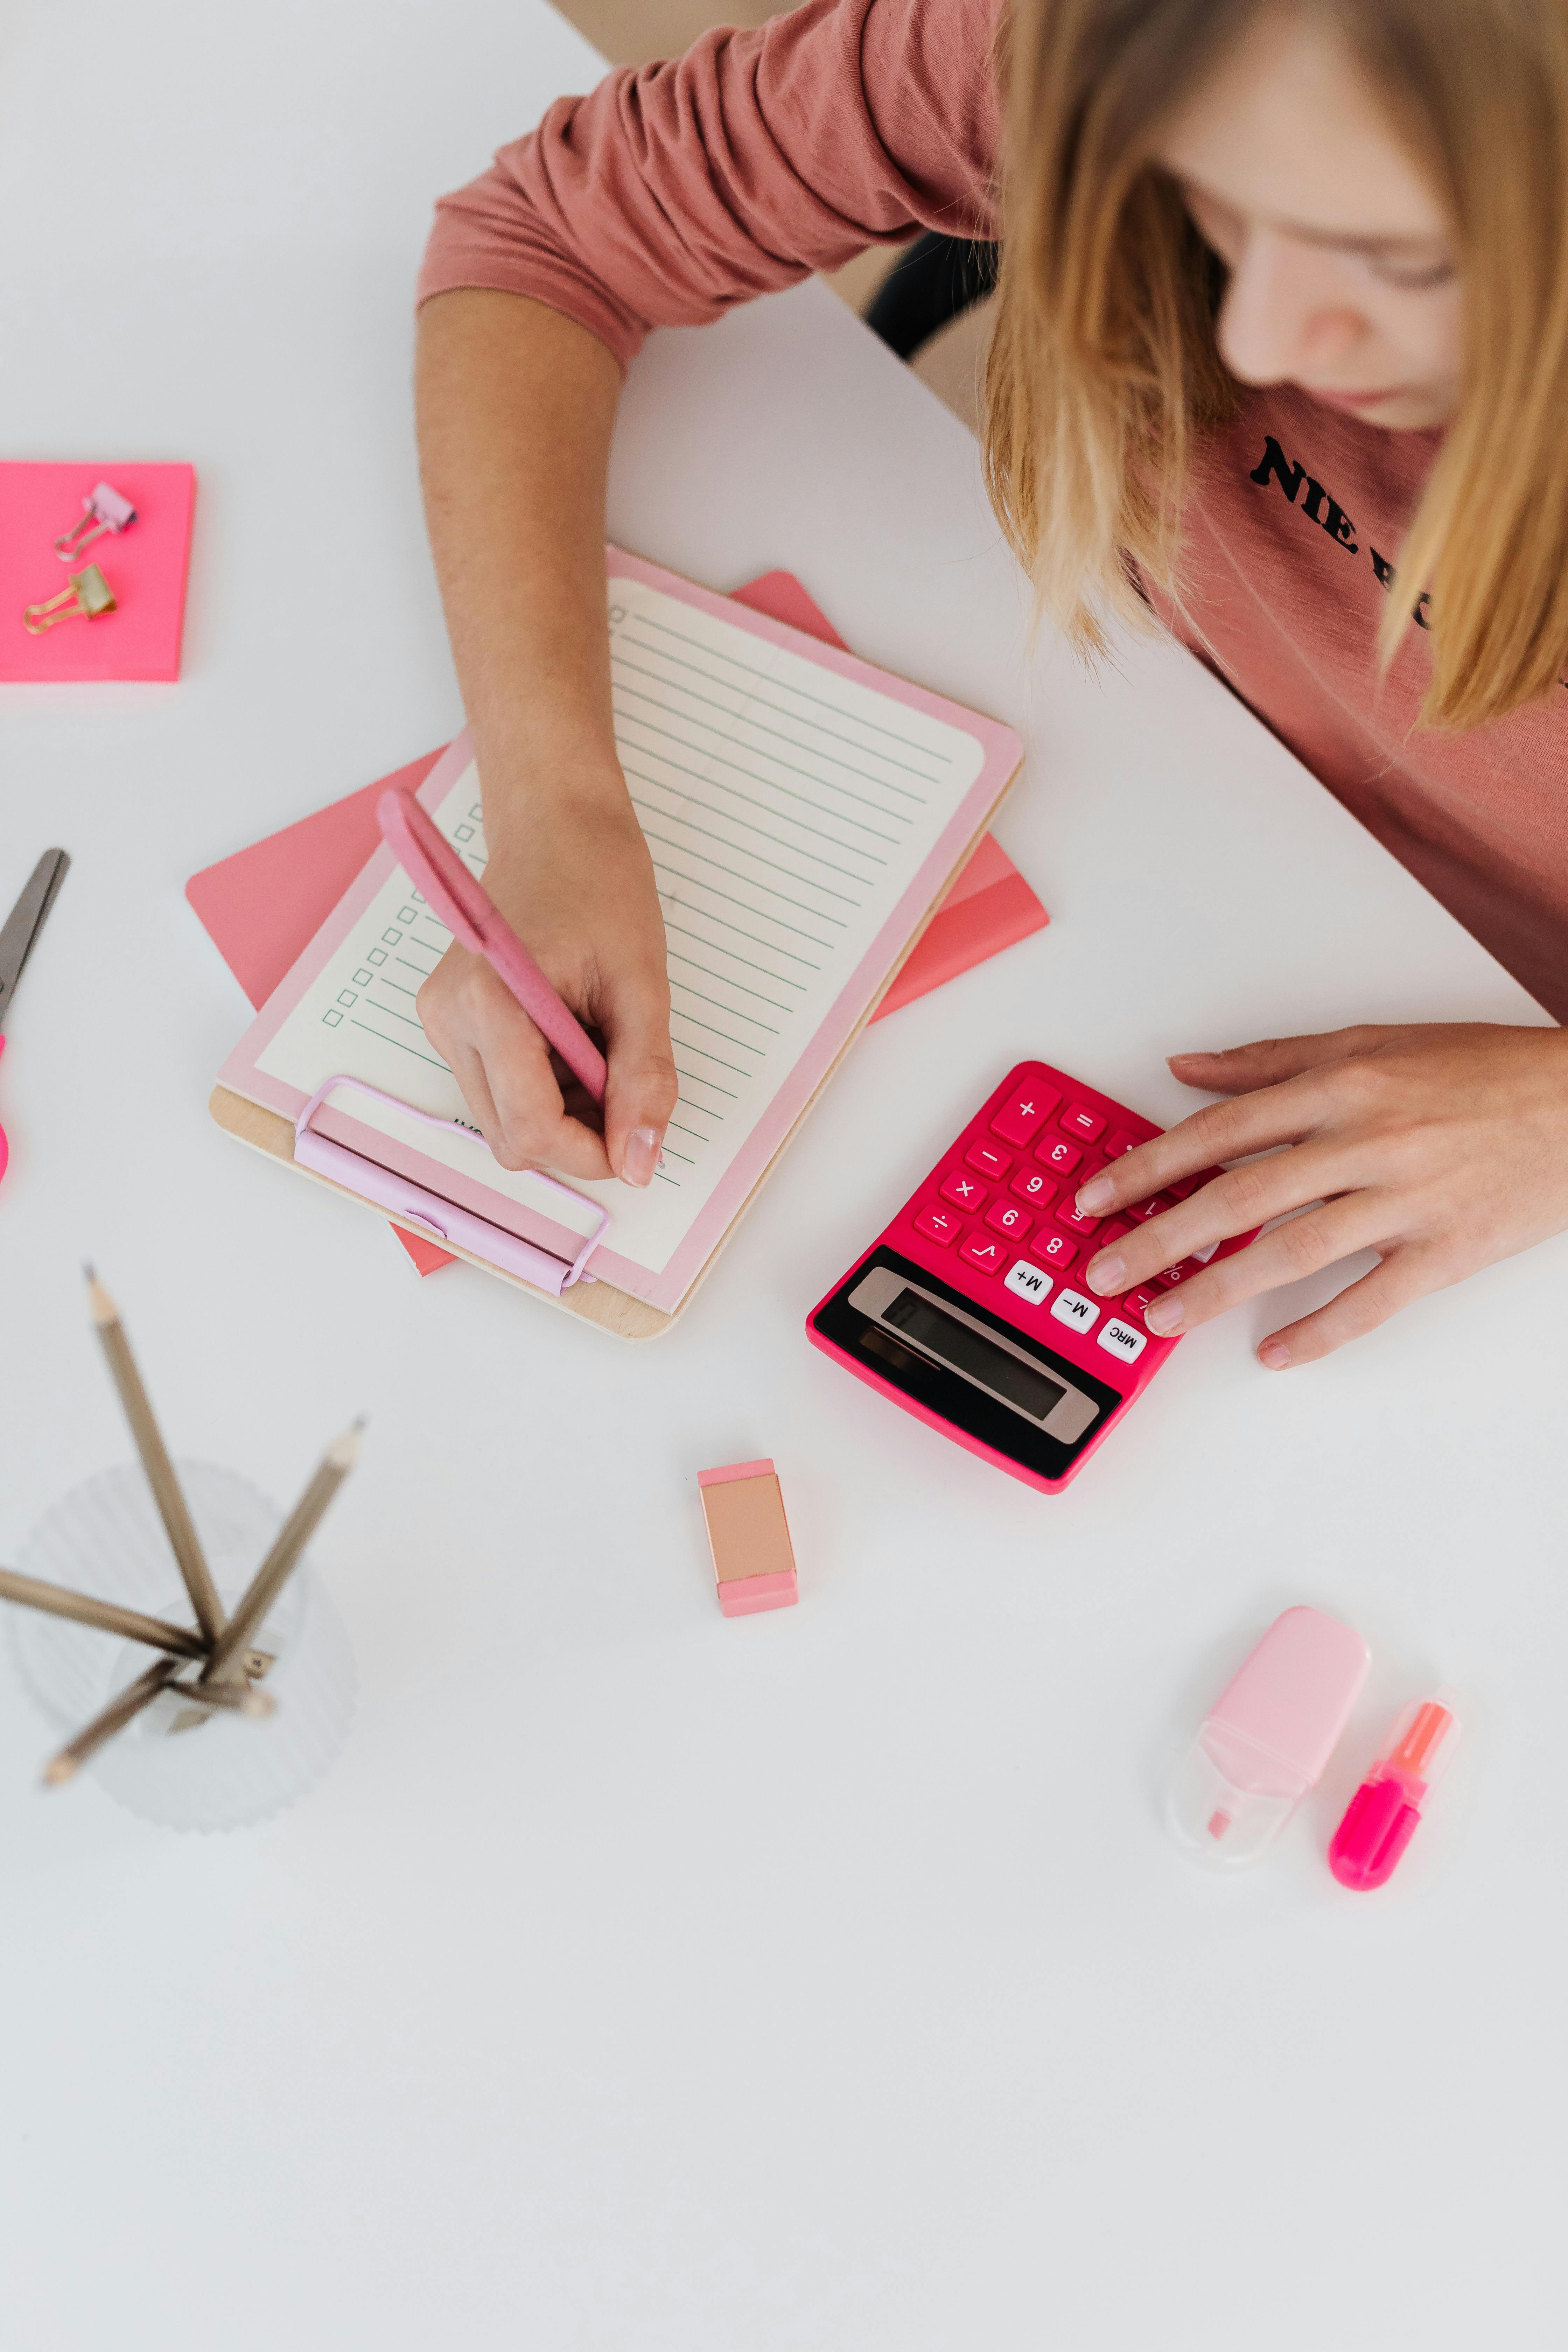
(1077, 1023, 1568, 1371)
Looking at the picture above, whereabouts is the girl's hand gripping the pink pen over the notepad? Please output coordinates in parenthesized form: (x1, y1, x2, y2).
(416, 769, 677, 1185)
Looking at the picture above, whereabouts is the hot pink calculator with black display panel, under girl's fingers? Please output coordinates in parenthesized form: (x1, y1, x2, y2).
(806, 1061, 1251, 1493)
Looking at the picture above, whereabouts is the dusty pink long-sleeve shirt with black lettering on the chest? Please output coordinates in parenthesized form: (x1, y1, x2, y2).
(419, 0, 1568, 1021)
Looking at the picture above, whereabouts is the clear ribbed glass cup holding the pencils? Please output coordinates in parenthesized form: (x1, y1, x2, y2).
(5, 1463, 355, 1830)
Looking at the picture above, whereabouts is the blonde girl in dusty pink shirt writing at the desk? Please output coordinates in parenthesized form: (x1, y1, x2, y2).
(419, 0, 1568, 1369)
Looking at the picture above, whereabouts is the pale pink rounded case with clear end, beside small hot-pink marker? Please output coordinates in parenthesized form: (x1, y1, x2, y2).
(1168, 1609, 1371, 1870)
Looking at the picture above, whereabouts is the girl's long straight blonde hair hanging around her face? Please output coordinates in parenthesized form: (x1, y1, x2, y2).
(985, 0, 1568, 729)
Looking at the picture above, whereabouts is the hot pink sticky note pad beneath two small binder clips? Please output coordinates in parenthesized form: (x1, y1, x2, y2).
(0, 458, 195, 685)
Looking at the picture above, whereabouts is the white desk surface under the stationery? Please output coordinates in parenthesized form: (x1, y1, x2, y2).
(0, 0, 1568, 2352)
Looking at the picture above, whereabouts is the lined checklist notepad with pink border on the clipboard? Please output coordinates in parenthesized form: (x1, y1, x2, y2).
(223, 555, 1018, 1308)
